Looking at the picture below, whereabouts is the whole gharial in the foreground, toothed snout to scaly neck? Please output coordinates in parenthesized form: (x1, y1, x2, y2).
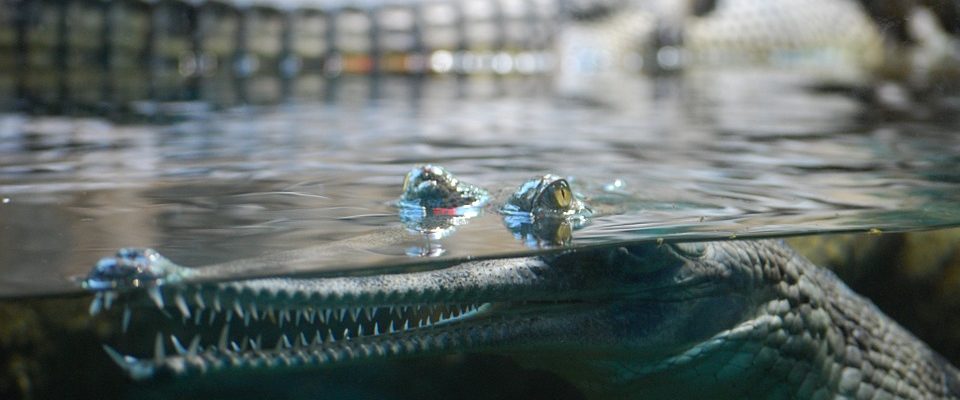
(85, 165, 960, 399)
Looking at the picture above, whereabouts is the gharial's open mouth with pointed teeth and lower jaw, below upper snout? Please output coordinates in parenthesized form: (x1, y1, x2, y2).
(105, 287, 497, 379)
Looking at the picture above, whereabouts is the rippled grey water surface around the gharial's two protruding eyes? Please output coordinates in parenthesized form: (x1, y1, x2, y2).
(0, 70, 960, 296)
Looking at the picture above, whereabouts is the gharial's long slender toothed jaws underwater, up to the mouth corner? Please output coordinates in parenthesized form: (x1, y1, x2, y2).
(91, 258, 584, 379)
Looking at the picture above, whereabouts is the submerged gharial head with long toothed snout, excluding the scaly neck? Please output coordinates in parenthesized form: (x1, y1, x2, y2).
(91, 239, 768, 396)
